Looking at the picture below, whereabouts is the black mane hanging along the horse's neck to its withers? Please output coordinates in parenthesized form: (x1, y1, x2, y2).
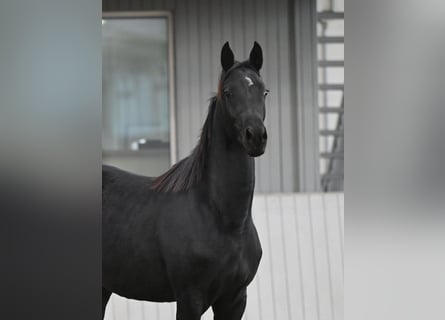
(151, 97, 217, 192)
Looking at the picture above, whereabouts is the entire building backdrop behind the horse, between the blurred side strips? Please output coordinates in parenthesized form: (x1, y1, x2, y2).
(102, 0, 344, 320)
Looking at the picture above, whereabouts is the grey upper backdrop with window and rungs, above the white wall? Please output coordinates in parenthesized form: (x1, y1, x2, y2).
(102, 0, 344, 192)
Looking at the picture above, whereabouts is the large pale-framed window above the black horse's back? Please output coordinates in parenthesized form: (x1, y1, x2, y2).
(102, 13, 176, 176)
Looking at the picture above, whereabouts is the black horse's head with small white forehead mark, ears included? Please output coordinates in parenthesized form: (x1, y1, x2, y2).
(218, 42, 268, 157)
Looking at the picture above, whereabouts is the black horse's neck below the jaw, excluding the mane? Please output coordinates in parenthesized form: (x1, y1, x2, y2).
(207, 106, 255, 231)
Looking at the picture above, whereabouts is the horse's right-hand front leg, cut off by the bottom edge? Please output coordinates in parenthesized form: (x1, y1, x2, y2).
(212, 288, 247, 320)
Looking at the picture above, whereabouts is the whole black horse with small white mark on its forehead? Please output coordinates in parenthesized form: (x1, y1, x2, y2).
(102, 42, 268, 320)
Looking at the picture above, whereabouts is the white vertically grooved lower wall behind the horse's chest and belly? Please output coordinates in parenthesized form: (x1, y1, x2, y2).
(105, 193, 344, 320)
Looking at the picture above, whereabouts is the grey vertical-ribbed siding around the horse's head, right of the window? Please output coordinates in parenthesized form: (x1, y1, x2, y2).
(102, 0, 297, 192)
